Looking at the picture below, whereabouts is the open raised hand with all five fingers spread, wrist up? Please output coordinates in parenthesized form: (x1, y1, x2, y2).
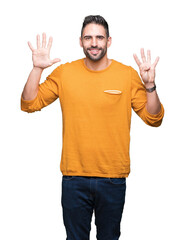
(28, 33, 61, 69)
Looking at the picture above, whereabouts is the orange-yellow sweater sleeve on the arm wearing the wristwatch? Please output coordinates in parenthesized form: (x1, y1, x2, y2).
(131, 67, 164, 127)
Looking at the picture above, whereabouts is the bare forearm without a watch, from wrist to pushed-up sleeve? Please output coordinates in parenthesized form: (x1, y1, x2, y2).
(22, 67, 43, 100)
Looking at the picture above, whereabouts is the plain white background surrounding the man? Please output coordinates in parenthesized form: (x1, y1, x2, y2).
(0, 0, 185, 240)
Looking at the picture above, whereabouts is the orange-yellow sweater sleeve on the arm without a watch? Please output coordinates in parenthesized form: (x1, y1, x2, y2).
(21, 65, 62, 113)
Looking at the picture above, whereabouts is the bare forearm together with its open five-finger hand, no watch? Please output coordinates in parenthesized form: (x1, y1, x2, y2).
(22, 33, 60, 100)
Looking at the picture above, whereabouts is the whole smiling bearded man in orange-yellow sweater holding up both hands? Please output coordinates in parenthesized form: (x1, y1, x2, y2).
(21, 15, 164, 240)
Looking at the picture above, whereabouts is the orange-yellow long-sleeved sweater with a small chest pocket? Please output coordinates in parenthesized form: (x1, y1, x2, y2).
(21, 58, 164, 178)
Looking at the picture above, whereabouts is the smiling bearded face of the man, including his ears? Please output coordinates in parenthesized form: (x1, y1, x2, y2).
(80, 23, 111, 61)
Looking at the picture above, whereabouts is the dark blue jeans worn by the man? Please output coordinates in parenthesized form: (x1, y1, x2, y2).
(61, 176, 126, 240)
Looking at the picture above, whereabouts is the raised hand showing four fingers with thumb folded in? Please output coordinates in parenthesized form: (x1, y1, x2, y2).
(133, 48, 159, 86)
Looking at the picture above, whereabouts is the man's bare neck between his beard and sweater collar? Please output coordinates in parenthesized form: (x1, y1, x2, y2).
(84, 57, 112, 71)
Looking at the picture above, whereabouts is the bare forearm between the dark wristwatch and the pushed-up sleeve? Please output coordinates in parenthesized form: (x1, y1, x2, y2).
(146, 82, 161, 114)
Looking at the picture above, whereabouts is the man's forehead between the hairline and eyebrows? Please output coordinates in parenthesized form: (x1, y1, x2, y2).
(83, 23, 106, 36)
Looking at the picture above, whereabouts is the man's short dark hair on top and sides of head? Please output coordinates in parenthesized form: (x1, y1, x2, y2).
(81, 15, 109, 38)
